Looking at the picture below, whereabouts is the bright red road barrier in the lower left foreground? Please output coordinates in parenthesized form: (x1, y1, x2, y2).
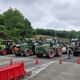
(0, 63, 25, 80)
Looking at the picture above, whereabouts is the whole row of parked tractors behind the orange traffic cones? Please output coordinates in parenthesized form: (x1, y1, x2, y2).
(0, 39, 79, 58)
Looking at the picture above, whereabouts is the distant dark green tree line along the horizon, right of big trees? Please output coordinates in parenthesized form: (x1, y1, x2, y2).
(35, 29, 80, 39)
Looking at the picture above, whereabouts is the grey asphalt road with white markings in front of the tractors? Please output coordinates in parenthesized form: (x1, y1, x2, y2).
(0, 55, 80, 80)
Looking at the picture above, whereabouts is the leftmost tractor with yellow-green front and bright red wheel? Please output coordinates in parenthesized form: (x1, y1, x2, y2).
(0, 40, 14, 55)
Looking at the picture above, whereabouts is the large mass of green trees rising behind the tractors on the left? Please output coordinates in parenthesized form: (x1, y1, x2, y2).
(0, 8, 32, 41)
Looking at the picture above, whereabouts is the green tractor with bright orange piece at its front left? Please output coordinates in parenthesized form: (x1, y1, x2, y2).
(12, 39, 35, 56)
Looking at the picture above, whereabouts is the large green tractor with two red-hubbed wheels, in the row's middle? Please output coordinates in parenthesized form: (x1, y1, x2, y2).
(36, 43, 62, 58)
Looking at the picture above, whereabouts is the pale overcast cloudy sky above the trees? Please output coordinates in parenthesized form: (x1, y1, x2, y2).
(0, 0, 80, 31)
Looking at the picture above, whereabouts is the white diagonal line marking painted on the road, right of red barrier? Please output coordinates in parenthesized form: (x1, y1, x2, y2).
(25, 57, 67, 80)
